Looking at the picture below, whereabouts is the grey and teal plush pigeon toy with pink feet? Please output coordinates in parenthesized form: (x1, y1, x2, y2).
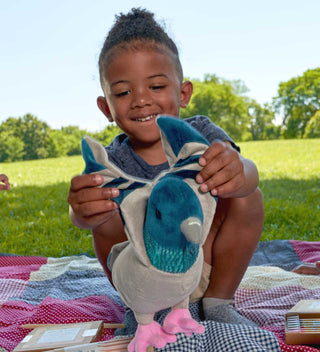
(82, 116, 216, 352)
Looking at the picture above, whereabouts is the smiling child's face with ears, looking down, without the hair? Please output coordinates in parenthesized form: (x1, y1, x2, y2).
(98, 50, 192, 145)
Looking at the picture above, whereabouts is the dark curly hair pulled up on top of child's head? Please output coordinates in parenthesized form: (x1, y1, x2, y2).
(99, 8, 183, 83)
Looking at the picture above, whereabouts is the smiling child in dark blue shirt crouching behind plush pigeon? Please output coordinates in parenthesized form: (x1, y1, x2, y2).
(68, 9, 264, 325)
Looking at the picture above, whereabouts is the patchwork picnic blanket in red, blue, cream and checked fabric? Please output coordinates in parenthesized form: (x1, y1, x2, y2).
(0, 240, 320, 352)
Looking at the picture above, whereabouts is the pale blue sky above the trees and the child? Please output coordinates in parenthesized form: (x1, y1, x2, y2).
(0, 0, 320, 131)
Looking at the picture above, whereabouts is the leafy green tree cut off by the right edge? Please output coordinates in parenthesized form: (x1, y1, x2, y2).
(274, 67, 320, 138)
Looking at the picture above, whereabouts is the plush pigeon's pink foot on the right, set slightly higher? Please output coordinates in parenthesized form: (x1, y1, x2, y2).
(163, 309, 205, 336)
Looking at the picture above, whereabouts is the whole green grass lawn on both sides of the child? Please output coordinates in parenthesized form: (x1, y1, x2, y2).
(0, 139, 320, 256)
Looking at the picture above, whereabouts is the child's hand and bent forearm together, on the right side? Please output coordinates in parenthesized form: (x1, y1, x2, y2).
(196, 141, 259, 198)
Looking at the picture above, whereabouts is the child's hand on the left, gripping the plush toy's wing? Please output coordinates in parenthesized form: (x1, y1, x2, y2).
(68, 174, 119, 229)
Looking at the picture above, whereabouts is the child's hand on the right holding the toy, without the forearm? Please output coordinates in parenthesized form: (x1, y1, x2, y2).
(196, 142, 246, 198)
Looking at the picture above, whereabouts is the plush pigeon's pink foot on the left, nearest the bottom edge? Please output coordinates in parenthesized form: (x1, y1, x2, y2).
(128, 321, 177, 352)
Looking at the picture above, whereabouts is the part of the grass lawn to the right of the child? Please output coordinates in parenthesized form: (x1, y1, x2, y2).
(241, 139, 320, 241)
